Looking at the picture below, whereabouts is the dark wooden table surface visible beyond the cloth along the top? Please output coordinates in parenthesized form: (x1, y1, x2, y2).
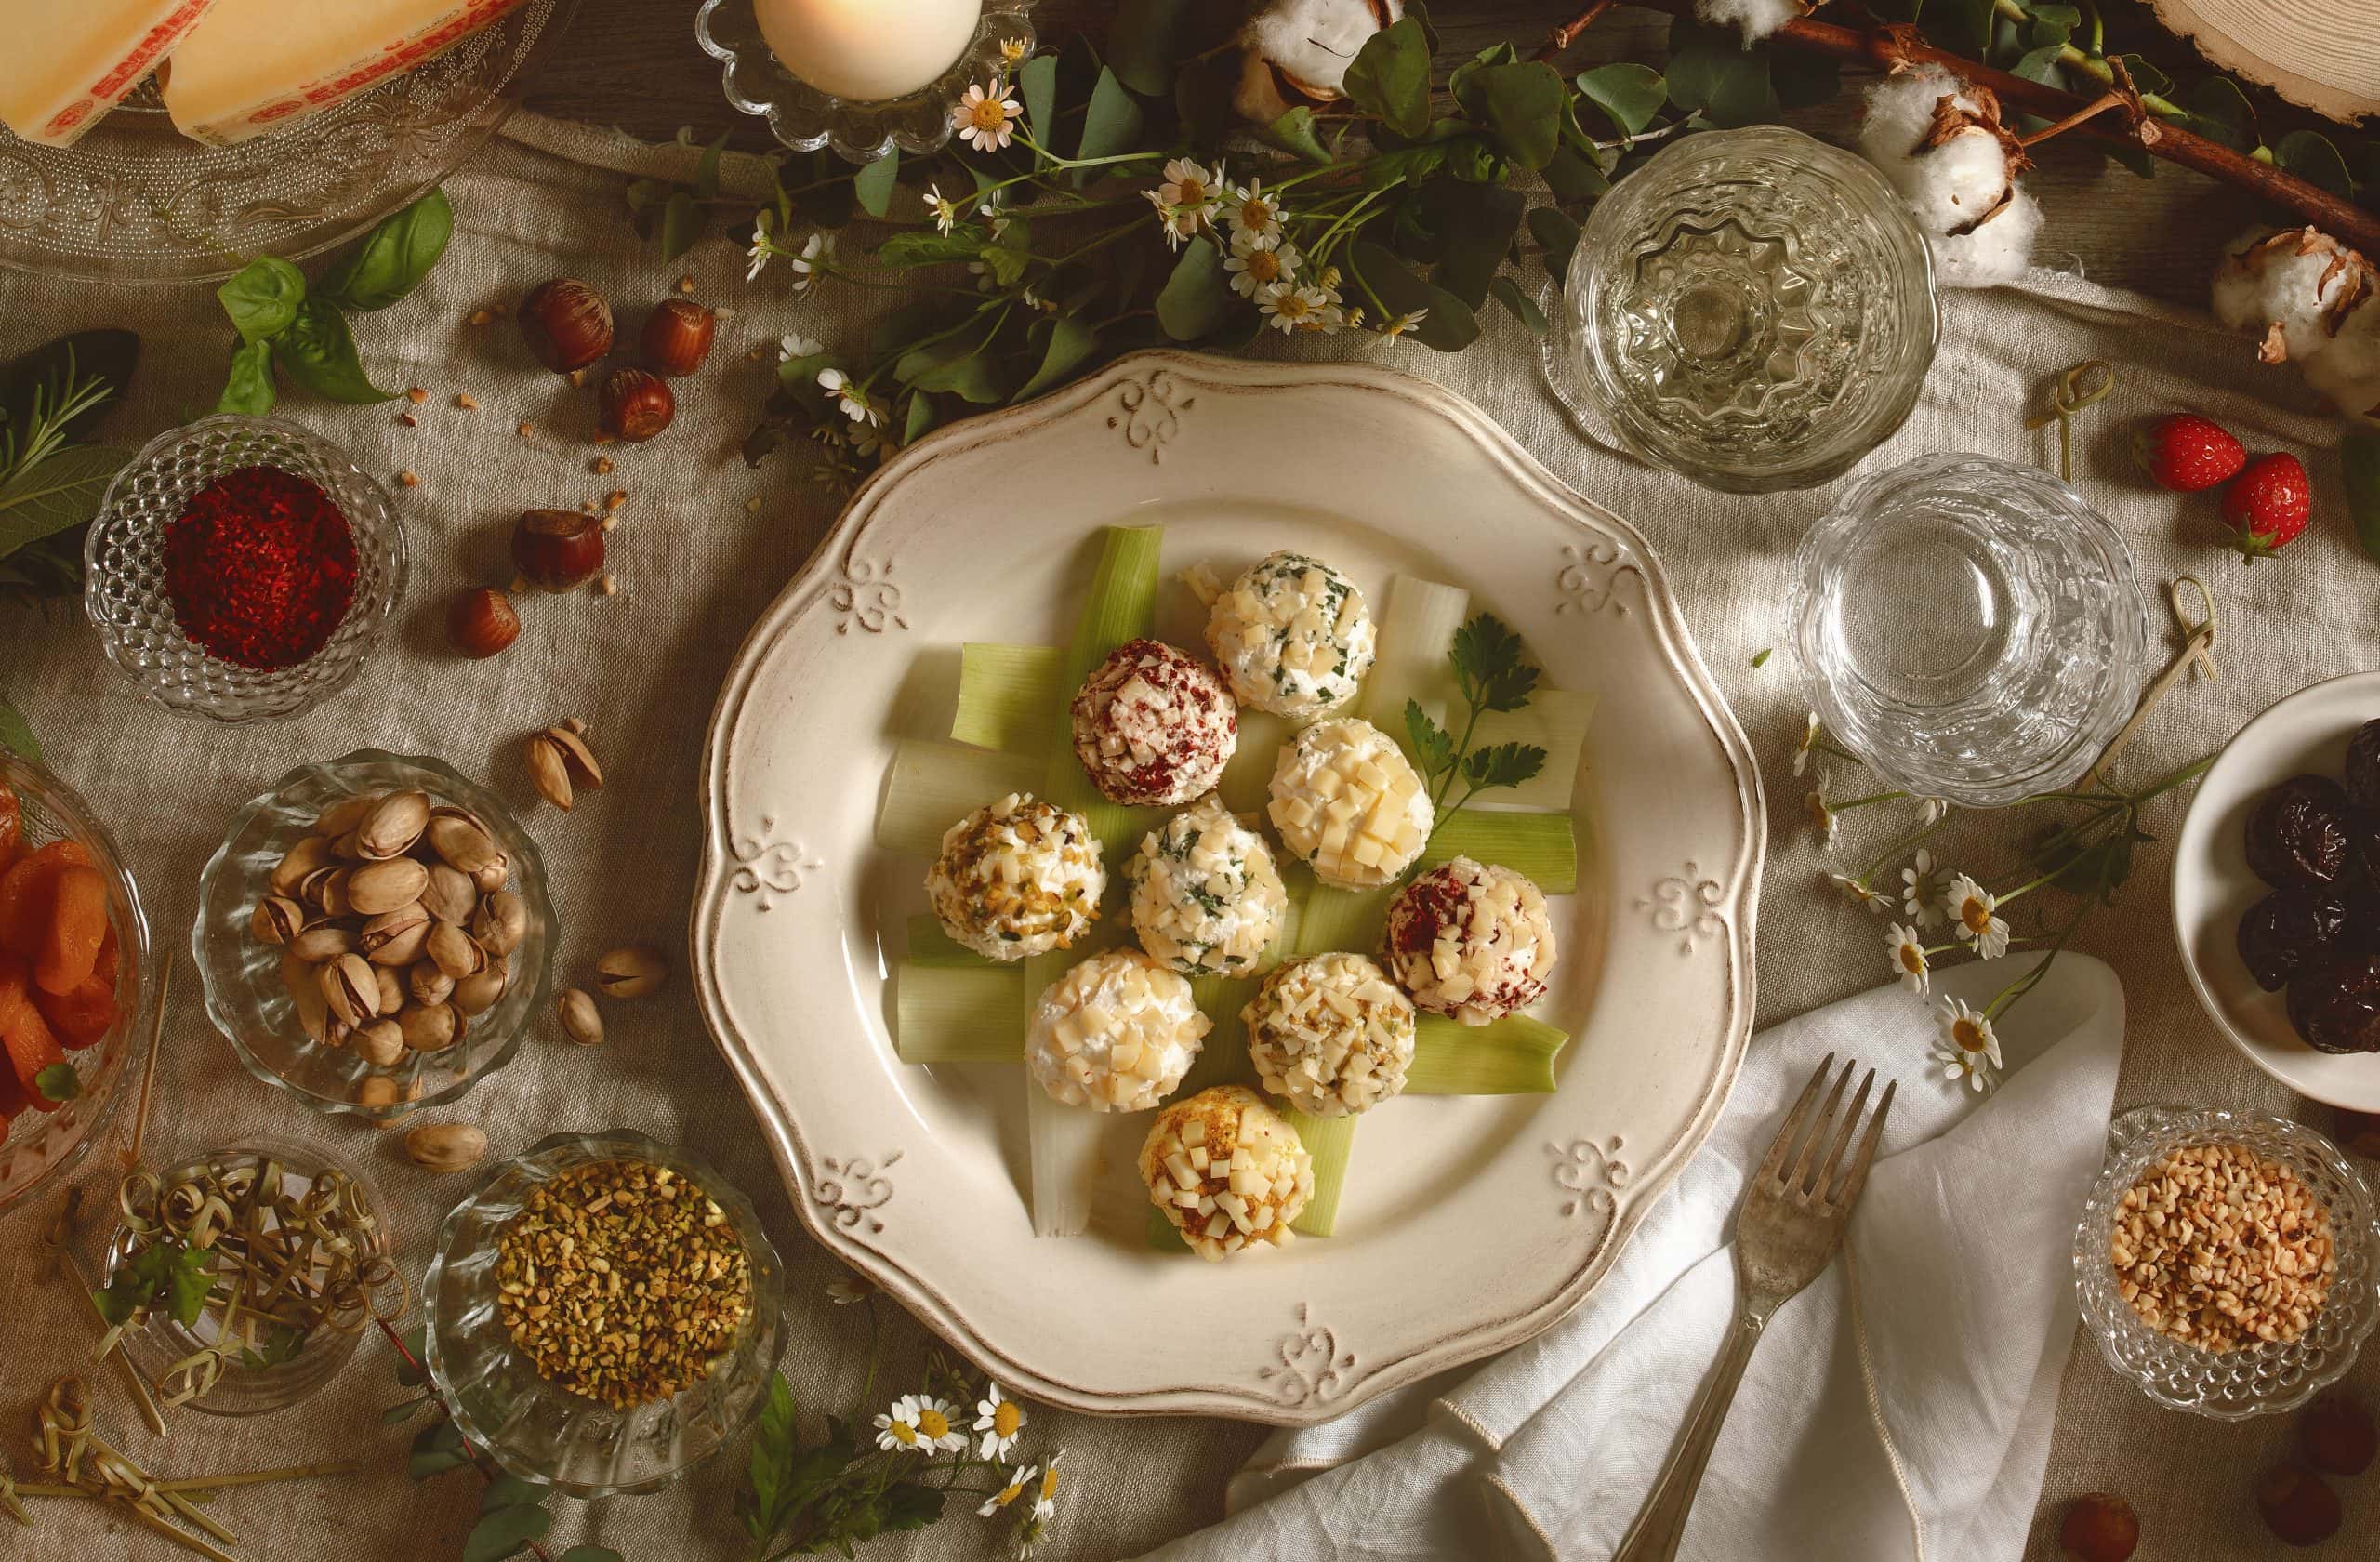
(528, 0, 2308, 316)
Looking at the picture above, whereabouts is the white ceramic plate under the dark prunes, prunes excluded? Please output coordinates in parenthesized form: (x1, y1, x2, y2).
(2173, 671, 2380, 1112)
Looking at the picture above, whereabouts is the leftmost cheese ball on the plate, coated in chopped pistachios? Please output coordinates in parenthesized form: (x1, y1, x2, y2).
(926, 793, 1106, 960)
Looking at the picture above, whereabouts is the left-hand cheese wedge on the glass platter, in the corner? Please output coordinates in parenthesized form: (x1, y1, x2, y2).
(0, 0, 214, 145)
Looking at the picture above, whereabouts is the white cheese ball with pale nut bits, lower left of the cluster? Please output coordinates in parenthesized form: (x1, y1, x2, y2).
(1025, 950, 1211, 1112)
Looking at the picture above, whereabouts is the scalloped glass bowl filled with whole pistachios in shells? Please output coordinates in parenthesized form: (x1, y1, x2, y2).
(191, 748, 554, 1121)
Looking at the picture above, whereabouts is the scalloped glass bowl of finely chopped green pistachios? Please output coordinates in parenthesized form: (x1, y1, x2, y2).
(421, 1129, 786, 1498)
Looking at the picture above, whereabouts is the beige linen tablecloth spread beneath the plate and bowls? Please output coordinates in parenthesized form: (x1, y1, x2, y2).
(0, 116, 2380, 1562)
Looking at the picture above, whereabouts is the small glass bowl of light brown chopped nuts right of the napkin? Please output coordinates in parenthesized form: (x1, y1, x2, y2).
(2073, 1107, 2380, 1422)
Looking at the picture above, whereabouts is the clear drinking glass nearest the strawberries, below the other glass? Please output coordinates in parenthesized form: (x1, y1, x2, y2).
(1792, 455, 2149, 807)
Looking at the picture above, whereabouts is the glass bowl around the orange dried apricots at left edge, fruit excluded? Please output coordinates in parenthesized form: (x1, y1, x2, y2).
(0, 748, 150, 1214)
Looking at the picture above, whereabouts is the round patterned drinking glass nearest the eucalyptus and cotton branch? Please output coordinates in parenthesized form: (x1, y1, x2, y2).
(1547, 126, 1939, 493)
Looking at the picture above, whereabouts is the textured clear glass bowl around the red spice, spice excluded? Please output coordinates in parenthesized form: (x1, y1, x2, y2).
(84, 417, 407, 721)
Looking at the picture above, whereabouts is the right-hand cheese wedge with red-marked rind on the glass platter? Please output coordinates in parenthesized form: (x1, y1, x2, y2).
(167, 0, 536, 145)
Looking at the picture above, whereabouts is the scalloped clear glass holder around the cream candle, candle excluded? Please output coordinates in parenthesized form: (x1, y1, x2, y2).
(695, 0, 1036, 162)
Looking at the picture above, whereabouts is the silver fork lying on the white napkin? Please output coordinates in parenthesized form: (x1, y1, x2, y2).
(1611, 1052, 1895, 1562)
